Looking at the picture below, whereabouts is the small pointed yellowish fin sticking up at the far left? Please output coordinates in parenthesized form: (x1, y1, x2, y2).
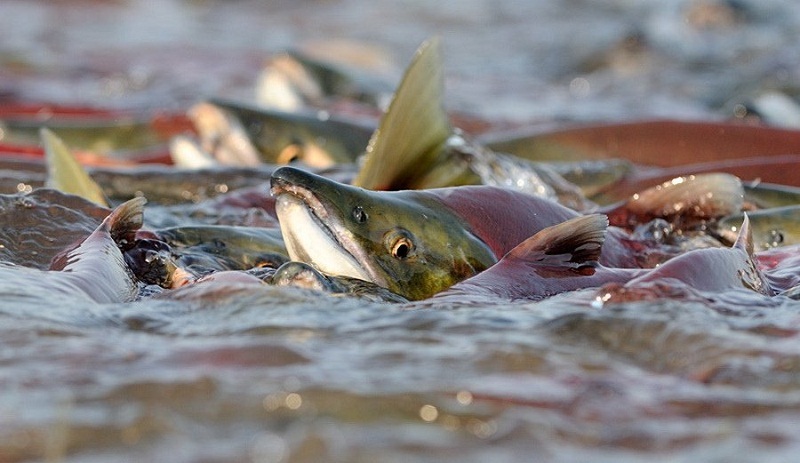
(40, 128, 108, 207)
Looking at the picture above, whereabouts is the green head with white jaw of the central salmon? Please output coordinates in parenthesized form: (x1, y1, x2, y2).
(271, 167, 497, 300)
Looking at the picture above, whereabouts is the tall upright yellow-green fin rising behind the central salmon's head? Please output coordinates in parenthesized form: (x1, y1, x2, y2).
(353, 37, 453, 190)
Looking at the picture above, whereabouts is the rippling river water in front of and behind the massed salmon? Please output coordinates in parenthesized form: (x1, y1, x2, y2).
(0, 0, 800, 462)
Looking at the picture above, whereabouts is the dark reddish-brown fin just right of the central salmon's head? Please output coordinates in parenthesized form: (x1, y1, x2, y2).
(503, 214, 608, 267)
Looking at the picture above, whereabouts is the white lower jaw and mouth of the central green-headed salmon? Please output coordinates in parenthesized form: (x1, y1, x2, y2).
(270, 168, 386, 285)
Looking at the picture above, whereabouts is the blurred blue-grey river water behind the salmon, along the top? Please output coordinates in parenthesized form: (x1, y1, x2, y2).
(0, 0, 800, 122)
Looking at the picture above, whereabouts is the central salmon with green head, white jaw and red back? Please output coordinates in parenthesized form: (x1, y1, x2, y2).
(271, 166, 652, 300)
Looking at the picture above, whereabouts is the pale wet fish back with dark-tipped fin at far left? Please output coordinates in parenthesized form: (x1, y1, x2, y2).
(0, 198, 145, 304)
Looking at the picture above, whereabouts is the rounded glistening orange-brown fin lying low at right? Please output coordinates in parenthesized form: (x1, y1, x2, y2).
(609, 173, 744, 226)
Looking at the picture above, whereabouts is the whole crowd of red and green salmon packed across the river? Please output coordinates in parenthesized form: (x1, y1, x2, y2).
(2, 38, 800, 307)
